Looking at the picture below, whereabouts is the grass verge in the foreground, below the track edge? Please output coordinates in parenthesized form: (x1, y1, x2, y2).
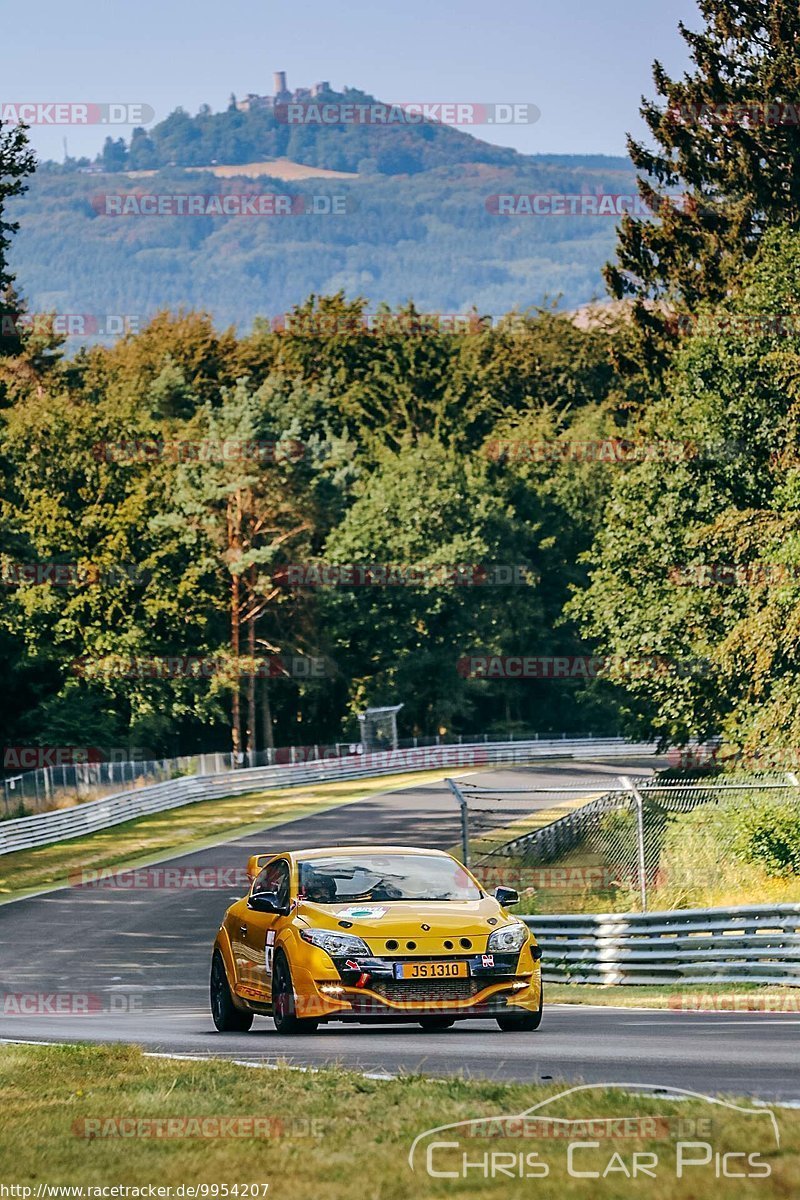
(0, 1034, 800, 1200)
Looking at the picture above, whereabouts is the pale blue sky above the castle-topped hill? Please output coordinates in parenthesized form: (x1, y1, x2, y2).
(0, 0, 700, 161)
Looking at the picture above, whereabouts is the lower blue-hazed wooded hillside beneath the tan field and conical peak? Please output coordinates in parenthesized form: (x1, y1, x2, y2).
(11, 152, 634, 330)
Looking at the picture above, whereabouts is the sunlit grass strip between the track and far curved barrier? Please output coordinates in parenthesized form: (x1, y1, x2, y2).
(0, 768, 470, 904)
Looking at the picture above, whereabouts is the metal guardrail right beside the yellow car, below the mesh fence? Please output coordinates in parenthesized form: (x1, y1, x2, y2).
(523, 904, 800, 988)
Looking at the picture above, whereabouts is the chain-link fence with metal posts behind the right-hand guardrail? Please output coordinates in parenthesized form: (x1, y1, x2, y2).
(449, 773, 800, 912)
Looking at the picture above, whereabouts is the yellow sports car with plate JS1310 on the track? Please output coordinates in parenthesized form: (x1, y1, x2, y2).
(211, 846, 542, 1033)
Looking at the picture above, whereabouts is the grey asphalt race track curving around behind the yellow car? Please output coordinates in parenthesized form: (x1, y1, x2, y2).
(0, 760, 800, 1103)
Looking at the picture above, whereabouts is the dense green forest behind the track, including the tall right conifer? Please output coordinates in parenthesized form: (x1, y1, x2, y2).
(0, 0, 800, 754)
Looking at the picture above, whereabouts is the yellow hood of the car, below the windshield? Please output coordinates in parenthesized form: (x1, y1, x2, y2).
(297, 896, 510, 937)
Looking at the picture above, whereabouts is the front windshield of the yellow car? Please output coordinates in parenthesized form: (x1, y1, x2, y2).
(300, 854, 482, 904)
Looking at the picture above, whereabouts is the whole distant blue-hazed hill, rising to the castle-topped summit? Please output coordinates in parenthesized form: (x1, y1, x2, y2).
(10, 87, 636, 329)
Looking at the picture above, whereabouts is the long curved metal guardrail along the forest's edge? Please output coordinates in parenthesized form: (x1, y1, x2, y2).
(0, 738, 655, 854)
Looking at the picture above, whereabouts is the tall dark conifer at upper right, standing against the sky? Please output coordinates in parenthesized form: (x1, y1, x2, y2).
(606, 0, 800, 328)
